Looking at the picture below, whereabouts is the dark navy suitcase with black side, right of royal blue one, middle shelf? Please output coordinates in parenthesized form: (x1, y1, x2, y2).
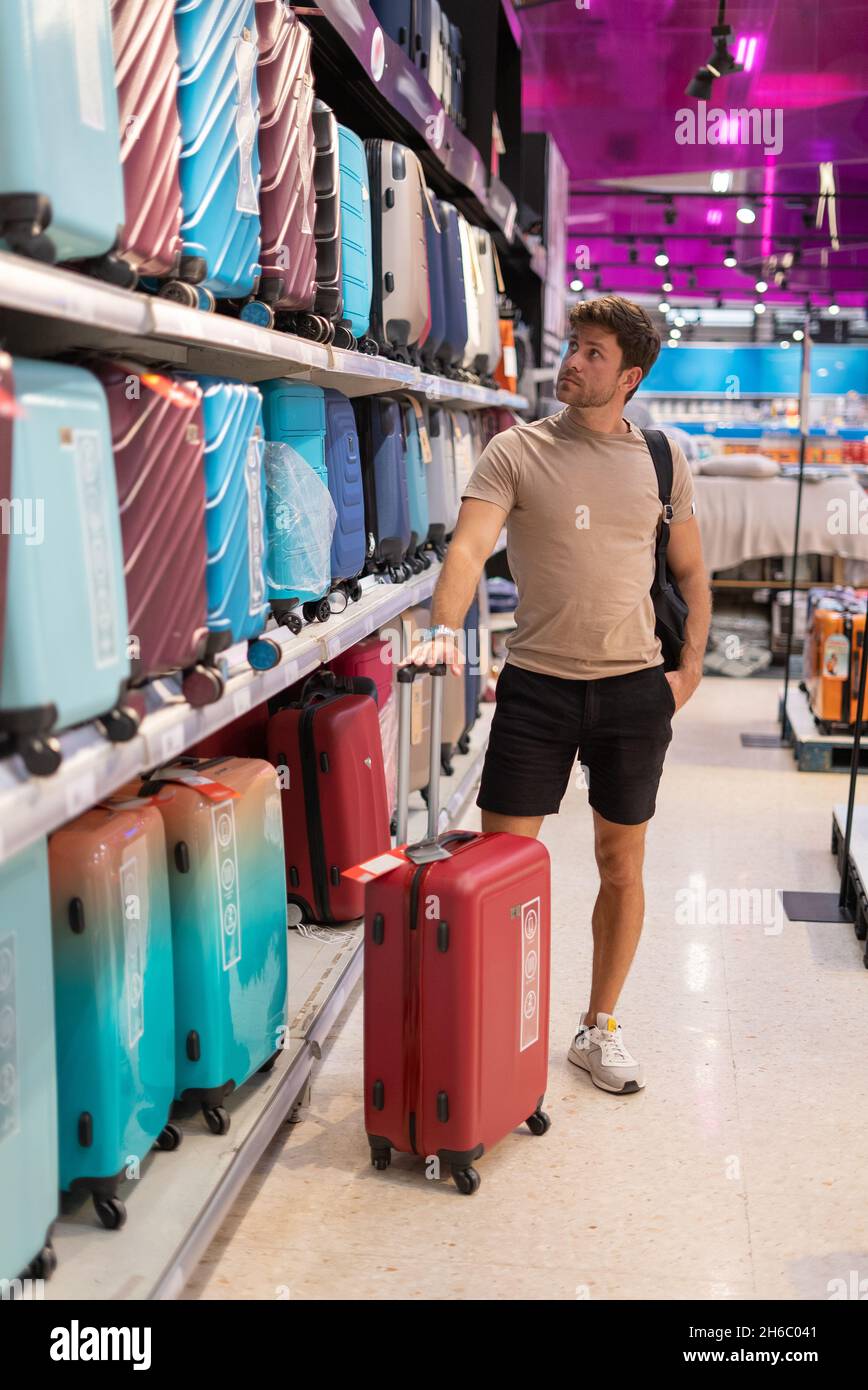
(353, 396, 410, 580)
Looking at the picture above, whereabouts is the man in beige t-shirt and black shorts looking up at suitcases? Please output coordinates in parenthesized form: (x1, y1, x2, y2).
(409, 295, 711, 1095)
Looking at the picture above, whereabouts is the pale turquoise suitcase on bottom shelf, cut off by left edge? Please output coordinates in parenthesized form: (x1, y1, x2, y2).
(0, 840, 57, 1279)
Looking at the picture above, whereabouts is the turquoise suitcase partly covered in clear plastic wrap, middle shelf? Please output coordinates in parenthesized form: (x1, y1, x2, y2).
(260, 379, 331, 631)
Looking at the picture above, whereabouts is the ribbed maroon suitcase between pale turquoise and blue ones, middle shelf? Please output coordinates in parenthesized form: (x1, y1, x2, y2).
(96, 361, 223, 705)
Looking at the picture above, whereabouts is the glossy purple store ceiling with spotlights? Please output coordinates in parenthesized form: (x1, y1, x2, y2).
(519, 0, 868, 304)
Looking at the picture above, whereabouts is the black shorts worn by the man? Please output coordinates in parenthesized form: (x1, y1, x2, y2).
(476, 662, 675, 826)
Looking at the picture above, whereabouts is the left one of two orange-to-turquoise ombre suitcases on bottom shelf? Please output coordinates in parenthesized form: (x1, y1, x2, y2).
(49, 796, 181, 1230)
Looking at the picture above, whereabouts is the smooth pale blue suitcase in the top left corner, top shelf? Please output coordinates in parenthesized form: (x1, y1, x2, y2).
(0, 0, 127, 276)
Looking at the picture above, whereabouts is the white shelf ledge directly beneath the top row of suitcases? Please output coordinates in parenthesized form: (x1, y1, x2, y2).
(0, 252, 527, 410)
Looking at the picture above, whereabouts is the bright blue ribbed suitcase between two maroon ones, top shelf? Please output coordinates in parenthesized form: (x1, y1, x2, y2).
(164, 0, 262, 307)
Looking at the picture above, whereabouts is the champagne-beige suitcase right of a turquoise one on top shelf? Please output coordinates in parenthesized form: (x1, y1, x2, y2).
(364, 140, 431, 361)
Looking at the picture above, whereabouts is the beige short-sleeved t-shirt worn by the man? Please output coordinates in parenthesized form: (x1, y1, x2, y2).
(462, 407, 694, 680)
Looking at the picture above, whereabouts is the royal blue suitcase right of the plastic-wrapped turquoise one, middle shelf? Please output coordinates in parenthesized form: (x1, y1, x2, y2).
(326, 389, 366, 599)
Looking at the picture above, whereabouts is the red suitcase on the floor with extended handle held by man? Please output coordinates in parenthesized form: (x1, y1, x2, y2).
(364, 666, 551, 1195)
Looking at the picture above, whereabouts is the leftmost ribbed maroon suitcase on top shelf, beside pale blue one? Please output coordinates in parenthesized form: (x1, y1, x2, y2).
(111, 0, 181, 275)
